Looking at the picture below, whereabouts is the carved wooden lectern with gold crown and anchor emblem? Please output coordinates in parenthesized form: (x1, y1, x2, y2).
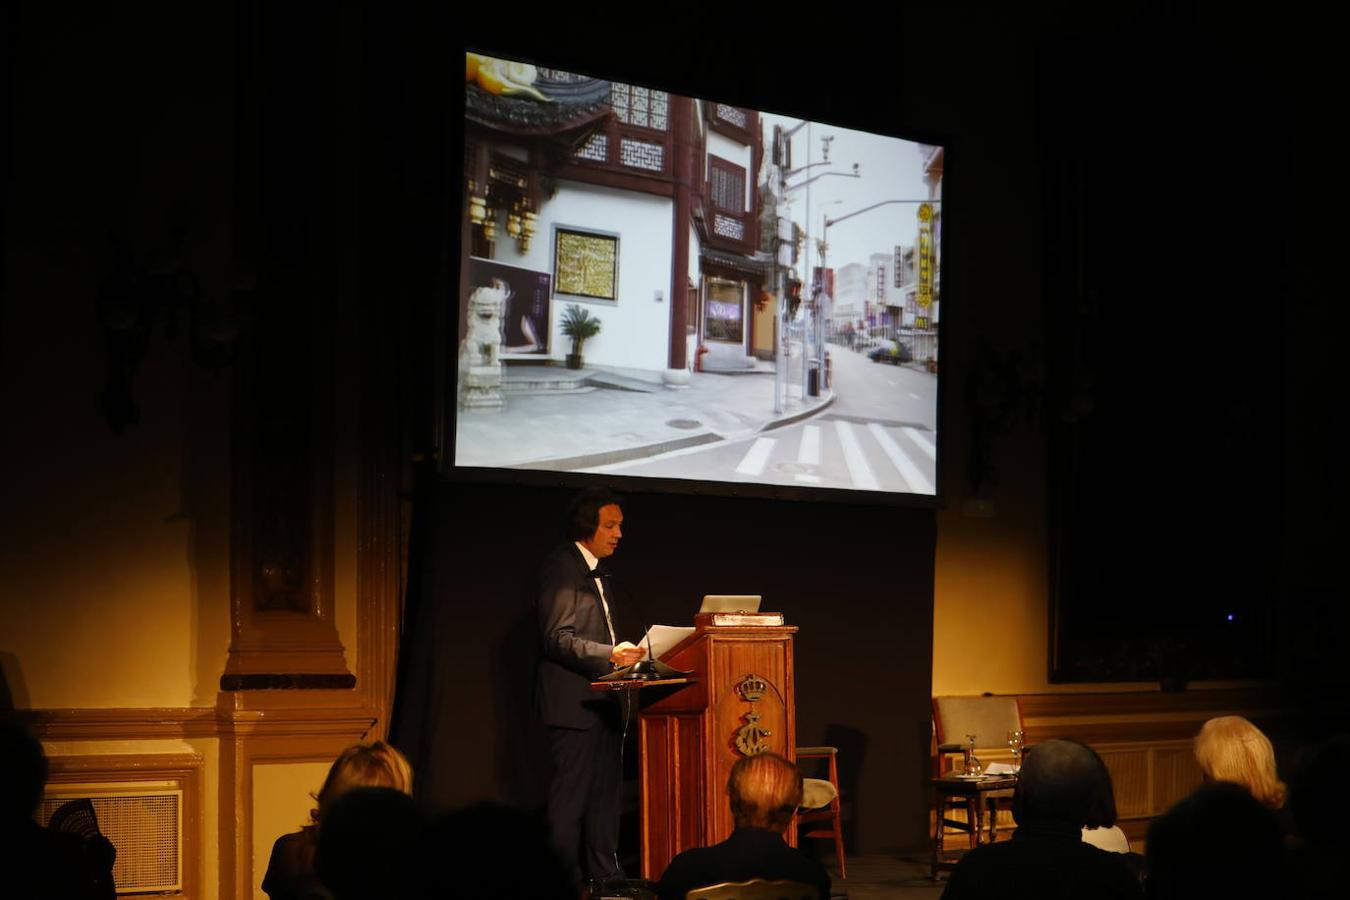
(639, 613, 797, 880)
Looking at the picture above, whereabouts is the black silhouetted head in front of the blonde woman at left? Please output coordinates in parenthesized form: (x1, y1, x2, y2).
(315, 787, 423, 900)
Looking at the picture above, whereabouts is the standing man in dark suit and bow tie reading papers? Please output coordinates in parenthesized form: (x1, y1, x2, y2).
(536, 490, 644, 884)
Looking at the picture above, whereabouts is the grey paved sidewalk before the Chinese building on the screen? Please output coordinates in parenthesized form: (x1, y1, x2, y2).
(455, 367, 834, 470)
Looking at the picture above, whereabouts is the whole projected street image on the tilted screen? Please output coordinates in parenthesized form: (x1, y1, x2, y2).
(454, 54, 944, 497)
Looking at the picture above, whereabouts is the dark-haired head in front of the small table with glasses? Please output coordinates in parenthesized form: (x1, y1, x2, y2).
(1013, 741, 1115, 828)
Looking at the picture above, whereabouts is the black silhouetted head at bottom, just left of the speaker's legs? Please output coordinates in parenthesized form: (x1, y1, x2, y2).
(419, 803, 576, 900)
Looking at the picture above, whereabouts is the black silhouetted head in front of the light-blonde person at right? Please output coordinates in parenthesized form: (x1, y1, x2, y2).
(1146, 781, 1284, 900)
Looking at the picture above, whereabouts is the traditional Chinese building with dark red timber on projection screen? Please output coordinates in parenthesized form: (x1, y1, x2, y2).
(459, 58, 772, 379)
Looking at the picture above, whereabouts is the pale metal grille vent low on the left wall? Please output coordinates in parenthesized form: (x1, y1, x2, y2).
(38, 791, 182, 895)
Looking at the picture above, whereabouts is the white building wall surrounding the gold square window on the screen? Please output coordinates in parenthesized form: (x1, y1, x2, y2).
(495, 181, 675, 372)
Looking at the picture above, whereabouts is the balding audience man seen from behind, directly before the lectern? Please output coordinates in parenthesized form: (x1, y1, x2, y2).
(656, 753, 830, 900)
